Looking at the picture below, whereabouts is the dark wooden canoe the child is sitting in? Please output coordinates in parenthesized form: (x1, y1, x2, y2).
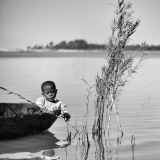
(0, 103, 58, 139)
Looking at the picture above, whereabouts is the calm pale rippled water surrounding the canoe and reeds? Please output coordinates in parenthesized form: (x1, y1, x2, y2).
(0, 53, 160, 160)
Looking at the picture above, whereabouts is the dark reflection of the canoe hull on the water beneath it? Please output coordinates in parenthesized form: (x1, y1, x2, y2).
(0, 131, 69, 155)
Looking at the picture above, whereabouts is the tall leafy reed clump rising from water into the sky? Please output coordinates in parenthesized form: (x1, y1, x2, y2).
(92, 0, 145, 137)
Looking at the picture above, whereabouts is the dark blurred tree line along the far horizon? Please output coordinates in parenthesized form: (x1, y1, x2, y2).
(27, 39, 160, 51)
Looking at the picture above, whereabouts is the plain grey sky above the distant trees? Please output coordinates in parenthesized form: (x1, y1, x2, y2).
(0, 0, 160, 49)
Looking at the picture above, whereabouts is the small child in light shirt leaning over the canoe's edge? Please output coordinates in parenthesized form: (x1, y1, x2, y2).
(36, 81, 71, 121)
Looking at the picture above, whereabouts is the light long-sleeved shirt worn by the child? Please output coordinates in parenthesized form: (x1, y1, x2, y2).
(36, 97, 68, 114)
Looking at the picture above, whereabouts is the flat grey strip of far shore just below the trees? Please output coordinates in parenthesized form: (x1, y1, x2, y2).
(0, 49, 160, 58)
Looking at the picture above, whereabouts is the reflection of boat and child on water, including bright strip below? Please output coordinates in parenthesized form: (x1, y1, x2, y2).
(0, 131, 70, 160)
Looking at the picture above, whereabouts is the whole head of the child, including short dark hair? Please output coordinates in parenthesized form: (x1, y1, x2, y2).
(41, 81, 57, 101)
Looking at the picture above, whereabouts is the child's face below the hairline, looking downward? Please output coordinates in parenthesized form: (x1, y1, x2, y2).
(42, 85, 57, 102)
